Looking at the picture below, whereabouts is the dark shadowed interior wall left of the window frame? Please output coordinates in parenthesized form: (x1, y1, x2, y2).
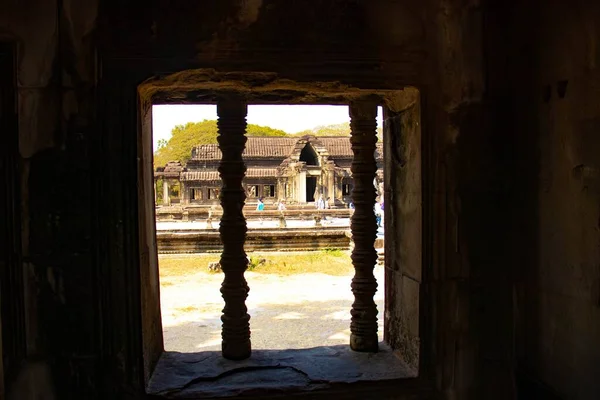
(0, 0, 99, 396)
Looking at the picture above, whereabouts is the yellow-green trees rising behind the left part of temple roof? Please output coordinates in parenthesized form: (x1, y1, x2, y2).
(154, 120, 287, 168)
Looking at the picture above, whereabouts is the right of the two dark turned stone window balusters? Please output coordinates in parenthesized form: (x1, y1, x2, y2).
(350, 100, 379, 352)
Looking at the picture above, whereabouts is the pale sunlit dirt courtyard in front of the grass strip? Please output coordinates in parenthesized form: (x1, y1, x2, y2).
(160, 256, 384, 352)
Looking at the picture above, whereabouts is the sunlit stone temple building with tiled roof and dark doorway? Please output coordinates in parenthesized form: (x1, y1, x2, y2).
(154, 135, 383, 207)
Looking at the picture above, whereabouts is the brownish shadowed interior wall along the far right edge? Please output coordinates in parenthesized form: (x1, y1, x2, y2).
(513, 1, 600, 399)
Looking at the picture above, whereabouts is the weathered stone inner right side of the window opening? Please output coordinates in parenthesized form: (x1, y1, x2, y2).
(379, 89, 423, 369)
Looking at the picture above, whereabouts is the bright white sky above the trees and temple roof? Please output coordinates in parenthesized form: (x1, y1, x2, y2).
(152, 105, 383, 150)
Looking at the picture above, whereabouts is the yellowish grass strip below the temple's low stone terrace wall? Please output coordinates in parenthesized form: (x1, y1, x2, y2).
(159, 249, 353, 278)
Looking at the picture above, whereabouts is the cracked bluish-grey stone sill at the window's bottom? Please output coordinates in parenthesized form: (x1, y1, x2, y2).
(149, 343, 416, 398)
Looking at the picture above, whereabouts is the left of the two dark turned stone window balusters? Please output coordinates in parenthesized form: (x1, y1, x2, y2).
(217, 97, 251, 360)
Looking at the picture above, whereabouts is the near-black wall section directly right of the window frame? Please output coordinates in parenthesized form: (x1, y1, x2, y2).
(420, 1, 516, 399)
